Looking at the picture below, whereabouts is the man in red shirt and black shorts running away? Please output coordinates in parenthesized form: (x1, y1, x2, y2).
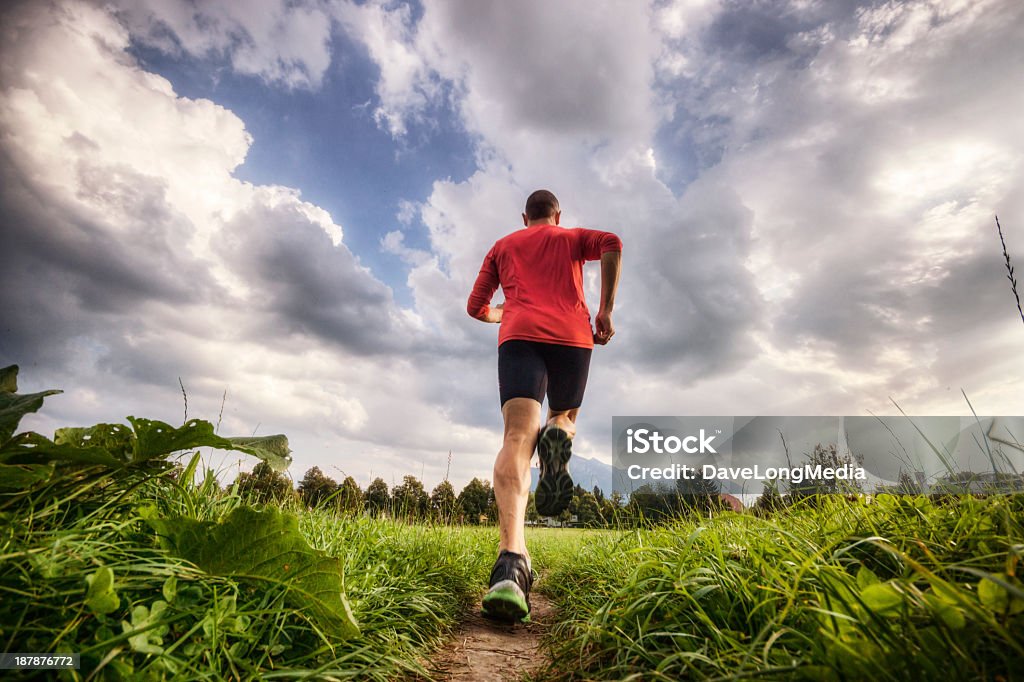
(466, 189, 623, 621)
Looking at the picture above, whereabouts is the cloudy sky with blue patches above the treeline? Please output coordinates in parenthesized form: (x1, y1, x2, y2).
(0, 0, 1024, 486)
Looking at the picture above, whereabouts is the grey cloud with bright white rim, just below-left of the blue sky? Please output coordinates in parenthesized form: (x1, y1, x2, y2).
(214, 197, 410, 355)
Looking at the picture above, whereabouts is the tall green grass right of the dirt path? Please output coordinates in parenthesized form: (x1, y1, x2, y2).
(542, 496, 1024, 680)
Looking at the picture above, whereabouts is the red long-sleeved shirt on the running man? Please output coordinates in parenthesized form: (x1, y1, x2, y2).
(466, 225, 623, 348)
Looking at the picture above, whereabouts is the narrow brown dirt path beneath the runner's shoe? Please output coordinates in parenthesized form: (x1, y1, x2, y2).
(430, 592, 554, 682)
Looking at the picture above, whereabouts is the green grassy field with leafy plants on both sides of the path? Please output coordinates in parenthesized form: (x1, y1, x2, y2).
(0, 376, 1024, 681)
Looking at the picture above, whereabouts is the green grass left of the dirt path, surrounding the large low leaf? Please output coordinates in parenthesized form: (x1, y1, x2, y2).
(0, 476, 497, 680)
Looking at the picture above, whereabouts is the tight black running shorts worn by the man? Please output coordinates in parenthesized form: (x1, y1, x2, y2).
(498, 339, 593, 412)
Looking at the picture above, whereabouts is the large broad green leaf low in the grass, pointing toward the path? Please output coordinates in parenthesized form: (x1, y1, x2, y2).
(140, 507, 358, 638)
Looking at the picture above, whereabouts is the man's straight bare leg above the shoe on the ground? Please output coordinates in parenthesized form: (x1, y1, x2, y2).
(495, 397, 541, 557)
